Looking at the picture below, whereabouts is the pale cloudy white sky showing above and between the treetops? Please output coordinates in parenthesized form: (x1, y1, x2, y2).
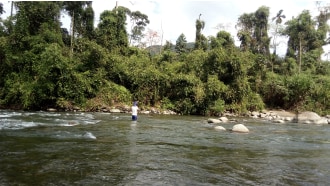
(3, 0, 328, 56)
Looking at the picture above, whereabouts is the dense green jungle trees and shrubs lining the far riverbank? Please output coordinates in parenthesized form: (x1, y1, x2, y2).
(0, 1, 330, 115)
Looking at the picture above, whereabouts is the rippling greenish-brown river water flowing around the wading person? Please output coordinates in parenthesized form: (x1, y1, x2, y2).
(0, 110, 330, 186)
